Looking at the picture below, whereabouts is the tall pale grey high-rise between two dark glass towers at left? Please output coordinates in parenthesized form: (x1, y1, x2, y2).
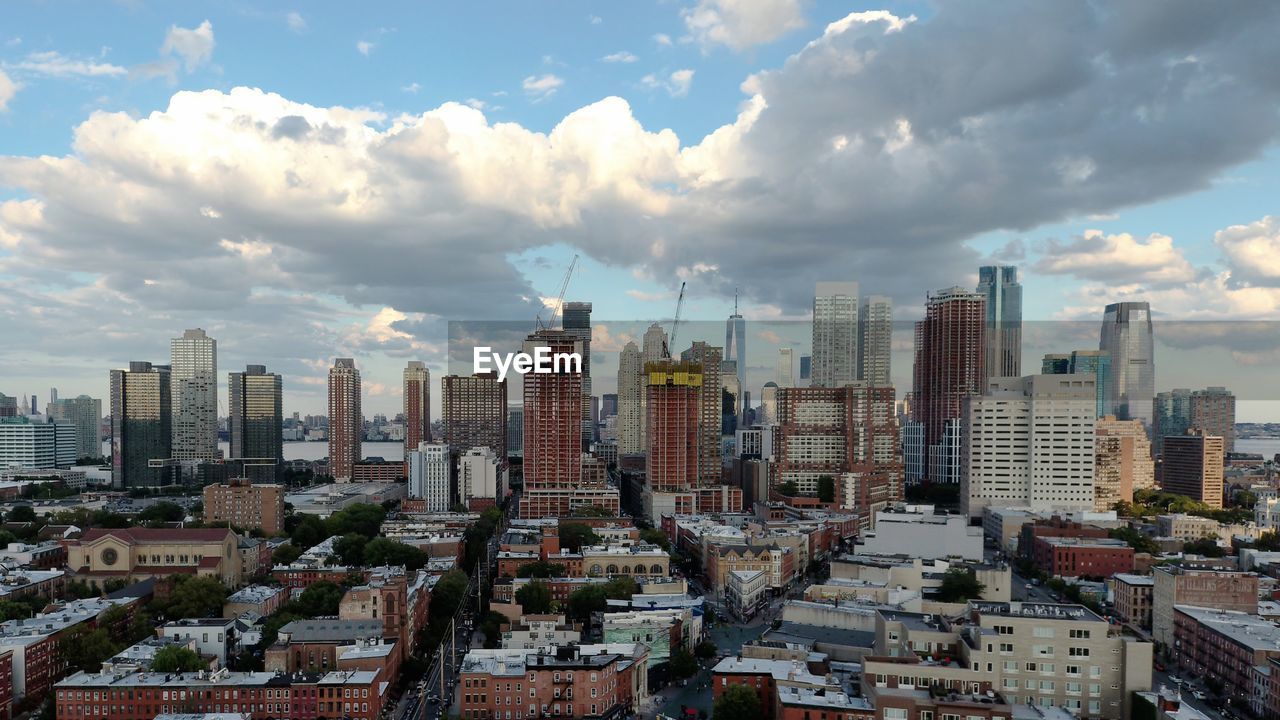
(169, 328, 218, 461)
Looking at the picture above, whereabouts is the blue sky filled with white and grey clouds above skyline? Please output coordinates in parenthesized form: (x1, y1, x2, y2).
(0, 0, 1280, 420)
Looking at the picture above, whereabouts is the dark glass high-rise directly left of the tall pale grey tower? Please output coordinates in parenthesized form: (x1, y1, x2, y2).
(110, 363, 173, 489)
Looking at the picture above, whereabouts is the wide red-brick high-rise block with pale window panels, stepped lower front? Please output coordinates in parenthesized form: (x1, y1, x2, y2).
(773, 380, 902, 528)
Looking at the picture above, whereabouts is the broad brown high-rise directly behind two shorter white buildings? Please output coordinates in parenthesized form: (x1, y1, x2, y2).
(440, 373, 506, 456)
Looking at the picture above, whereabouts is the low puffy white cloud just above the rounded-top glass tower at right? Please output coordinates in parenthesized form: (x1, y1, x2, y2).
(1034, 231, 1197, 286)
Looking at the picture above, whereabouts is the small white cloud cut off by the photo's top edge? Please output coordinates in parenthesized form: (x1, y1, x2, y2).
(681, 0, 805, 50)
